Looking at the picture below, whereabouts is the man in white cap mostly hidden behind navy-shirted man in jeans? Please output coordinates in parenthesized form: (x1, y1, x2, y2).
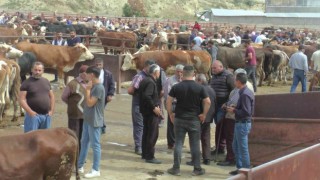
(217, 68, 254, 166)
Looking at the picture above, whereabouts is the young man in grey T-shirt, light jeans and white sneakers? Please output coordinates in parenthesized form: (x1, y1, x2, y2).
(78, 66, 105, 178)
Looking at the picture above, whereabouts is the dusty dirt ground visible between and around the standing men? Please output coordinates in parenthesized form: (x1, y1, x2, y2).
(0, 75, 301, 180)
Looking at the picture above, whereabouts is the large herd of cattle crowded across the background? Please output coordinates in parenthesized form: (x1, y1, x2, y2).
(0, 12, 320, 179)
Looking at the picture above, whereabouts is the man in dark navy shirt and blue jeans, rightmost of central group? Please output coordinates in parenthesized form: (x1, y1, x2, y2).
(227, 73, 254, 175)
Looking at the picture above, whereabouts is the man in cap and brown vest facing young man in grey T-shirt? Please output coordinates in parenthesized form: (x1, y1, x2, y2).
(61, 65, 88, 149)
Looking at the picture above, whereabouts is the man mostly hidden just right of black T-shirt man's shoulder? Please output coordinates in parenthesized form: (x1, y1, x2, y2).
(196, 74, 216, 165)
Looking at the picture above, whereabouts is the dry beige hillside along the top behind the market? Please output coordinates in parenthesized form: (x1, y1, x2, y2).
(0, 0, 264, 19)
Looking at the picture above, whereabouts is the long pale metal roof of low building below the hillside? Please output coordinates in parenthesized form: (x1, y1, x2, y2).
(211, 9, 265, 16)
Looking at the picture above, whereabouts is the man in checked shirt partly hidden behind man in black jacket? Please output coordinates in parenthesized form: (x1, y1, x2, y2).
(128, 60, 154, 155)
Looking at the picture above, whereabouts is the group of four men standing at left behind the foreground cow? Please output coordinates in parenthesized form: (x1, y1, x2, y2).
(20, 58, 115, 178)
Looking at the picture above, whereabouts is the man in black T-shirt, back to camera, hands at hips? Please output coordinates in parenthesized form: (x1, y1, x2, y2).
(167, 65, 210, 176)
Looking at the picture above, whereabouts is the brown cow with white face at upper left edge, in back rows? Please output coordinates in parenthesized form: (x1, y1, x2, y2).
(0, 27, 28, 44)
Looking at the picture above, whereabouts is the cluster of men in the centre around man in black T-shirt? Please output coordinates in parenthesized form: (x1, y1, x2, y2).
(128, 55, 254, 175)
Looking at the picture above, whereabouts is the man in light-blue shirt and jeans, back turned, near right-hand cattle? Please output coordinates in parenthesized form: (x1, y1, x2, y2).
(289, 45, 308, 93)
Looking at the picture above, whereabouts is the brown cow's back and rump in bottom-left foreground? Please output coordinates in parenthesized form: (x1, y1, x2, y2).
(0, 127, 80, 180)
